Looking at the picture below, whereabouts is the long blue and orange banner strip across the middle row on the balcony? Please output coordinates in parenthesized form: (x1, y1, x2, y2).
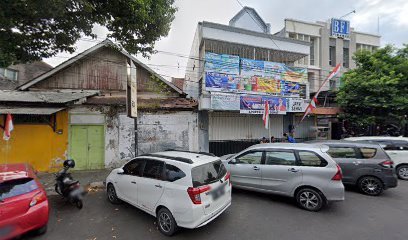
(205, 72, 306, 98)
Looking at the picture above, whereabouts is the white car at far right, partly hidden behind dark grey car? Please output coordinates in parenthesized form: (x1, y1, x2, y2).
(344, 136, 408, 180)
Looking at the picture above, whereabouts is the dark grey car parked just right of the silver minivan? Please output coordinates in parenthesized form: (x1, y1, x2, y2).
(313, 140, 398, 196)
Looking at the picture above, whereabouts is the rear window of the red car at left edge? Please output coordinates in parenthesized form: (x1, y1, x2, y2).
(0, 178, 38, 201)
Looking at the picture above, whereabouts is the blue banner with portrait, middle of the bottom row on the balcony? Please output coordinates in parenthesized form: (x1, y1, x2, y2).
(240, 96, 287, 114)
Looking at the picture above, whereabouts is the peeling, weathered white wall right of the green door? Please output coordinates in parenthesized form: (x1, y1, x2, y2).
(70, 106, 198, 167)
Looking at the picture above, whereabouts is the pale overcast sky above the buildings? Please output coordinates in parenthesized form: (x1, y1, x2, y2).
(45, 0, 408, 77)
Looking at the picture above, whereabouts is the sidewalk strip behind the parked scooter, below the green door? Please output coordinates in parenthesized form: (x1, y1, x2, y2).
(37, 169, 111, 195)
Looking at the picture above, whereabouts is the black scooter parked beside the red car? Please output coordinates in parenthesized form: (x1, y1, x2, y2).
(55, 160, 85, 209)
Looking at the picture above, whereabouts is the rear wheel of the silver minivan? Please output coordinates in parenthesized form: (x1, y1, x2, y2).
(296, 188, 324, 212)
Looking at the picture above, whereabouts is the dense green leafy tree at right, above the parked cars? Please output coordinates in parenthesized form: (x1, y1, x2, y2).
(337, 45, 408, 134)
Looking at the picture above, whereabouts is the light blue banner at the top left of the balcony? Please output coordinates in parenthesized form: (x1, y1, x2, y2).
(205, 52, 239, 75)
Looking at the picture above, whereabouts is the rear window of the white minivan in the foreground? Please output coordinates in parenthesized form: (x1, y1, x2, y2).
(191, 160, 227, 187)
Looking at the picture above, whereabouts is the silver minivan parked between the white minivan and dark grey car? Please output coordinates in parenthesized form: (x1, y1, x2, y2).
(221, 143, 344, 211)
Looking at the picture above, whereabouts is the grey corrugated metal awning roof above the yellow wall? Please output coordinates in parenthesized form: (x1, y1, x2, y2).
(0, 90, 99, 103)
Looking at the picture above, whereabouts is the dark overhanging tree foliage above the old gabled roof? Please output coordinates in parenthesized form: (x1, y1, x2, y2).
(0, 0, 177, 67)
